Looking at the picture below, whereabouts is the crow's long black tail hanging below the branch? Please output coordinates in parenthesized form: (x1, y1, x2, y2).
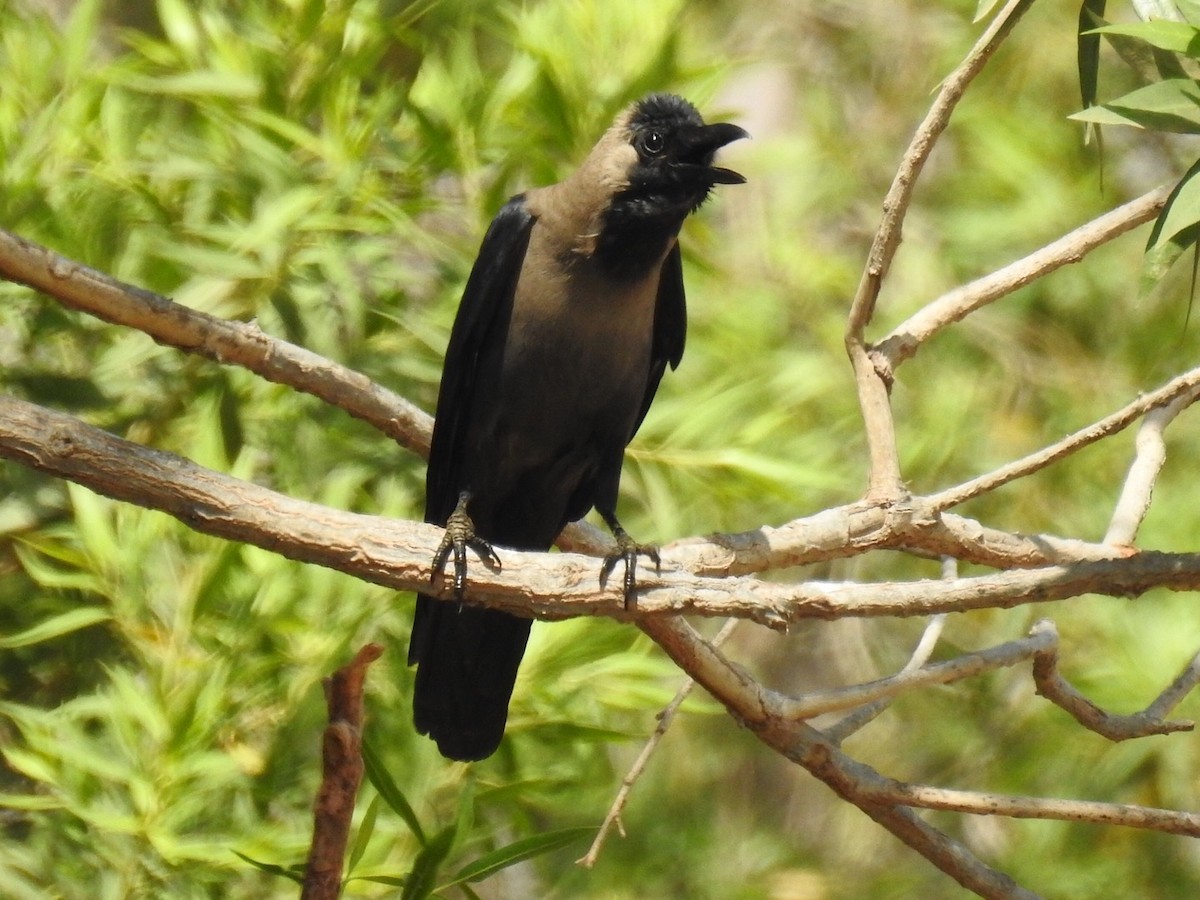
(408, 594, 533, 762)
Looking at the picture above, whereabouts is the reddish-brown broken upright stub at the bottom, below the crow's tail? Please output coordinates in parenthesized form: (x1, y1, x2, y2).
(300, 643, 383, 900)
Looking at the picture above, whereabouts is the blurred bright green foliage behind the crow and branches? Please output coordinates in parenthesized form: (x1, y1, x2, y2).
(0, 0, 1200, 900)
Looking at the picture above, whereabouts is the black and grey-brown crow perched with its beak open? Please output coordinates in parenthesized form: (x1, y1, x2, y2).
(408, 94, 749, 762)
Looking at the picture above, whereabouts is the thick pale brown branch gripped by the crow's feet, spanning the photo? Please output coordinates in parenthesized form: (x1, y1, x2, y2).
(11, 397, 1200, 629)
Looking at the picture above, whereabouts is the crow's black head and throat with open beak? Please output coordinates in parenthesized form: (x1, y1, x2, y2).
(598, 94, 750, 274)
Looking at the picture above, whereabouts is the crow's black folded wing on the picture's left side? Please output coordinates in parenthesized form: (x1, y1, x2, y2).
(425, 194, 534, 524)
